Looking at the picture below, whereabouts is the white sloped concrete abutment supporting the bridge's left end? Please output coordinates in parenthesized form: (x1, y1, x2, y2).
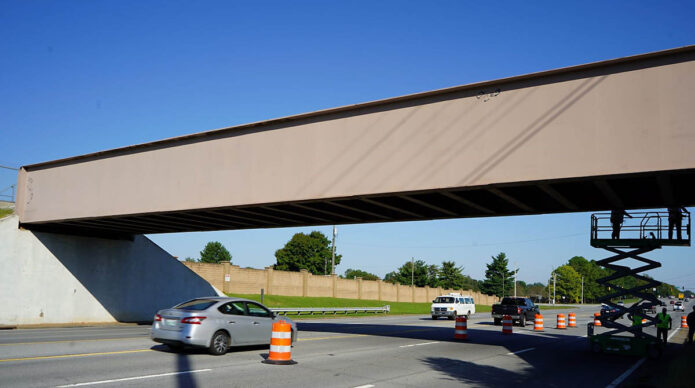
(0, 216, 217, 326)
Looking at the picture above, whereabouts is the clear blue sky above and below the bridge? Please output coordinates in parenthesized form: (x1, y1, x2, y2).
(0, 0, 695, 288)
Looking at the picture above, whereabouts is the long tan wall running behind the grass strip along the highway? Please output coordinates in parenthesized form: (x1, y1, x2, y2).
(193, 262, 499, 307)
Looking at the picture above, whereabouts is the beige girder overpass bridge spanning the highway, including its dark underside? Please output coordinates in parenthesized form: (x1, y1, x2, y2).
(17, 46, 695, 237)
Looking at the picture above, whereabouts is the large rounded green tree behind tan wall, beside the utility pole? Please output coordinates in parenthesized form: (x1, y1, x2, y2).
(274, 231, 342, 275)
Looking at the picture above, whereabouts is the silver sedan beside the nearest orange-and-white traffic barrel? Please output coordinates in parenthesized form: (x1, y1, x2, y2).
(150, 297, 297, 355)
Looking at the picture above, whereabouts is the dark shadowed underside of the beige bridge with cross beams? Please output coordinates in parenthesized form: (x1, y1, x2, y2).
(23, 170, 695, 237)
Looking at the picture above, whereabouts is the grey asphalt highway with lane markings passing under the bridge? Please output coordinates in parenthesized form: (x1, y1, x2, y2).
(0, 303, 692, 388)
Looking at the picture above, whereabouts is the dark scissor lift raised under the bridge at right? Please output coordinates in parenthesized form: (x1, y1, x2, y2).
(588, 210, 690, 357)
